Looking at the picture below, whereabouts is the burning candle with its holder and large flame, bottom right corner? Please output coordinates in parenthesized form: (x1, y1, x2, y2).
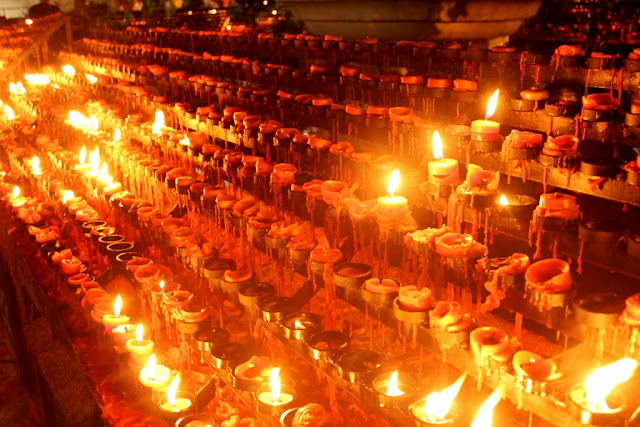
(569, 358, 638, 425)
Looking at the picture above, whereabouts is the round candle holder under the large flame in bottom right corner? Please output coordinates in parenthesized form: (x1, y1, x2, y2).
(567, 384, 626, 426)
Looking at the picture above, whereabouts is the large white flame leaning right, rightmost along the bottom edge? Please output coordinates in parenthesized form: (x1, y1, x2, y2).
(584, 358, 638, 411)
